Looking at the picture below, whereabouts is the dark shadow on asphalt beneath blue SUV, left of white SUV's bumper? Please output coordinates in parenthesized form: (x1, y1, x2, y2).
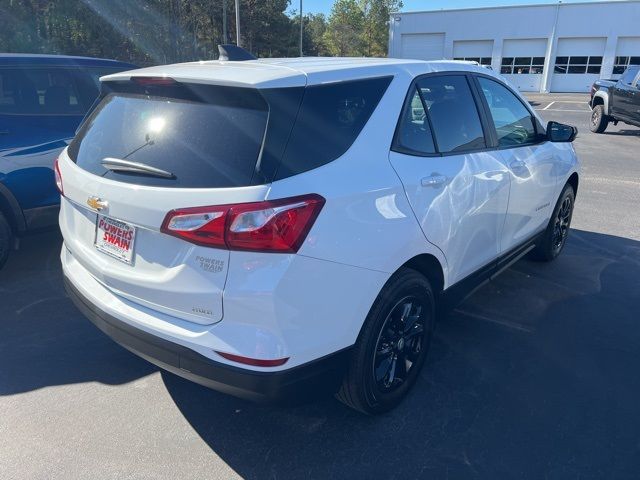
(0, 231, 157, 396)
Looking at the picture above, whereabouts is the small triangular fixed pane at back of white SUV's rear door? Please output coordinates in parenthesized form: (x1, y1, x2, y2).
(393, 87, 436, 155)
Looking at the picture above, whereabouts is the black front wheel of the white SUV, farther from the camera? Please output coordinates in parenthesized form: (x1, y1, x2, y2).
(531, 184, 576, 262)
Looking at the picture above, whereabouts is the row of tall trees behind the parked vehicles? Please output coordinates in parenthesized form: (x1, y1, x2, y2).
(0, 0, 401, 66)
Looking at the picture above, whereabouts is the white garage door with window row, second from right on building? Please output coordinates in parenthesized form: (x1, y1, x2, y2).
(551, 37, 607, 92)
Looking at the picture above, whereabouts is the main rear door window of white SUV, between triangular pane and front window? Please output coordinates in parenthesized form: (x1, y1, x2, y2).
(418, 75, 486, 153)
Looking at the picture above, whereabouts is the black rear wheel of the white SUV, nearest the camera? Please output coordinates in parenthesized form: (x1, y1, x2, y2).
(336, 268, 435, 415)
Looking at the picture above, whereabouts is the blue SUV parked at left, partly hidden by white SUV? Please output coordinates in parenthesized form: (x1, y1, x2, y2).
(0, 54, 137, 268)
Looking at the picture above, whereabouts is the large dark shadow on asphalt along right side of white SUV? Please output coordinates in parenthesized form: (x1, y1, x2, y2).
(162, 230, 640, 478)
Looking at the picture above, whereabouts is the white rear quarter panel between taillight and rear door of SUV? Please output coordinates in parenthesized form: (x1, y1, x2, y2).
(269, 71, 446, 278)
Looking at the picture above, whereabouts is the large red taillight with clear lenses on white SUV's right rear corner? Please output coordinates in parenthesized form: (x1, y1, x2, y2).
(160, 194, 325, 253)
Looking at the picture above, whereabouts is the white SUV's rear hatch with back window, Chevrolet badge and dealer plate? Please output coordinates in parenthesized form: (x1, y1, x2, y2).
(59, 77, 303, 324)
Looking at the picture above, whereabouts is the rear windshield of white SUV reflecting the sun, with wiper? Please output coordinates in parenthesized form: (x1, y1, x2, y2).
(68, 86, 269, 188)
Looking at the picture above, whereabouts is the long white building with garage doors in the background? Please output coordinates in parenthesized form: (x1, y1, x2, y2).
(389, 1, 640, 92)
